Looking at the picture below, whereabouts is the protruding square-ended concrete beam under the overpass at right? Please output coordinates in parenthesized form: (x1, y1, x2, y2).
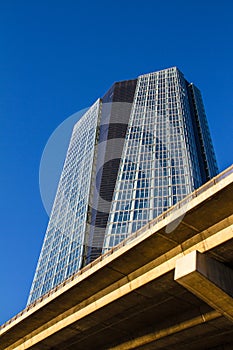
(174, 250, 233, 322)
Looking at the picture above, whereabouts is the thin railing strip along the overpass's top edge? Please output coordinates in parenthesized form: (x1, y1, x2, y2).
(0, 165, 233, 330)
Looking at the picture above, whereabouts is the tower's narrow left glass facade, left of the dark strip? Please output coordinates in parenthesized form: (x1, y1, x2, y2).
(28, 100, 100, 304)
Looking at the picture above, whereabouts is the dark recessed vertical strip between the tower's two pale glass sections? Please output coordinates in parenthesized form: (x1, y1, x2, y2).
(84, 79, 137, 264)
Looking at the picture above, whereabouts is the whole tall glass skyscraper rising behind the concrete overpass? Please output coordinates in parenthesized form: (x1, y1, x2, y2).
(28, 67, 218, 304)
